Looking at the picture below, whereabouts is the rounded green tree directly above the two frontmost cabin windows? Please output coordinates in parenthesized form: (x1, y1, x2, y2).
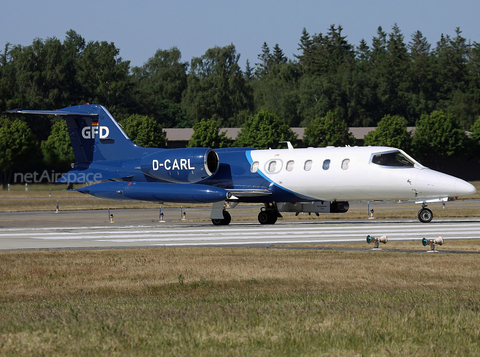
(303, 111, 355, 147)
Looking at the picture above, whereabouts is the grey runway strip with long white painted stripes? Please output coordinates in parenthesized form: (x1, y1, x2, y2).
(0, 212, 480, 250)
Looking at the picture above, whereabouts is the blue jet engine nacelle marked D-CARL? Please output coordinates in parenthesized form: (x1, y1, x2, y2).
(140, 148, 220, 183)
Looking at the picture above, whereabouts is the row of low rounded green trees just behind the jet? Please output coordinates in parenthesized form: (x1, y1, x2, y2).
(0, 109, 480, 185)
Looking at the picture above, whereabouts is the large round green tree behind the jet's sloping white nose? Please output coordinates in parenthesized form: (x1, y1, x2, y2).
(412, 110, 468, 169)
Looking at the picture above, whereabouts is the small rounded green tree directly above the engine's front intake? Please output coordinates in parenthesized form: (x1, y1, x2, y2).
(187, 118, 231, 149)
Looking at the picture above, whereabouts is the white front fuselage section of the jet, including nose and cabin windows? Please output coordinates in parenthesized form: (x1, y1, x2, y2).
(247, 146, 475, 202)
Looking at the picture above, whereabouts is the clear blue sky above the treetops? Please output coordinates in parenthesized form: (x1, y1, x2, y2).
(0, 0, 480, 67)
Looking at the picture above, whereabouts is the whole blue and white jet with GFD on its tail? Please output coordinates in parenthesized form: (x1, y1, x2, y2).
(7, 104, 476, 225)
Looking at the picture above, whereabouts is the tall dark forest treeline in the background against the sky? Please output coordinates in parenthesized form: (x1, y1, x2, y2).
(0, 25, 480, 135)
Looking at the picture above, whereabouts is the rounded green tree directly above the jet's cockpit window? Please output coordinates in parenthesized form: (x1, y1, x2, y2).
(364, 114, 412, 151)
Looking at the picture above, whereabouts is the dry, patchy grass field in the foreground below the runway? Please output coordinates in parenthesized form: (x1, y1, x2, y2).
(0, 245, 480, 356)
